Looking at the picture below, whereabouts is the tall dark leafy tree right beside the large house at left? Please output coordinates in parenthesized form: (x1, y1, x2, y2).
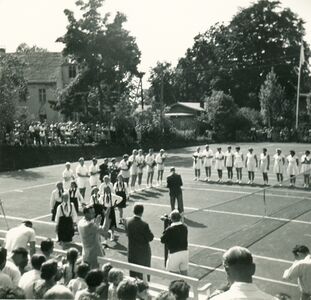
(57, 0, 140, 118)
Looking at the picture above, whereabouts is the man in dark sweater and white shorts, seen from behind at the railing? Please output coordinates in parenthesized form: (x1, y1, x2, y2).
(161, 210, 189, 275)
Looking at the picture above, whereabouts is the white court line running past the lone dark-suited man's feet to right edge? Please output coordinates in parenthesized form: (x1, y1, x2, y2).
(136, 202, 311, 225)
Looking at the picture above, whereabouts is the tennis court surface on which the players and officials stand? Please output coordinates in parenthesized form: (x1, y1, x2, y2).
(0, 143, 311, 299)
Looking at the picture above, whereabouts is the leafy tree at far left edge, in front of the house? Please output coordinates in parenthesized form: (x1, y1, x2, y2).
(0, 55, 28, 139)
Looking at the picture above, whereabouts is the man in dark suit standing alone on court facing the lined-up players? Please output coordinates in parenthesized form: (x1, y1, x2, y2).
(166, 167, 184, 218)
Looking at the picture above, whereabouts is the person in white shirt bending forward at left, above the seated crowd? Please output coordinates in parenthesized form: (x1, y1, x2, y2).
(5, 221, 36, 256)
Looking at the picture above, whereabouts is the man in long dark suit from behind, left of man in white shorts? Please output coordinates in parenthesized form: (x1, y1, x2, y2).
(125, 204, 154, 279)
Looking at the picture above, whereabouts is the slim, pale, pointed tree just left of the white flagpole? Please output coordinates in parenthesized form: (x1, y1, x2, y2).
(259, 69, 288, 127)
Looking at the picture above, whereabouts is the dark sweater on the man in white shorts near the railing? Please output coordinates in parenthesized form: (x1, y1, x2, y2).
(161, 224, 188, 253)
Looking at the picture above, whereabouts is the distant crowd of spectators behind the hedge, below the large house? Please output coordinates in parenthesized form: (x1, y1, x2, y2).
(4, 121, 115, 146)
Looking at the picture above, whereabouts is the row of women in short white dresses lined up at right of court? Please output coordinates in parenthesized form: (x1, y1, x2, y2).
(192, 145, 311, 188)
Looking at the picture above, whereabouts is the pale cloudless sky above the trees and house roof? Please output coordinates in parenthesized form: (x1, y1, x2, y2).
(0, 0, 311, 84)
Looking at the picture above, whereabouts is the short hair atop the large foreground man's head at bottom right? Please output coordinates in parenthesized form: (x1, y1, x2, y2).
(223, 246, 253, 266)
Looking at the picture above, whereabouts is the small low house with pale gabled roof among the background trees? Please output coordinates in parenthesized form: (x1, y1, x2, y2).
(165, 102, 204, 130)
